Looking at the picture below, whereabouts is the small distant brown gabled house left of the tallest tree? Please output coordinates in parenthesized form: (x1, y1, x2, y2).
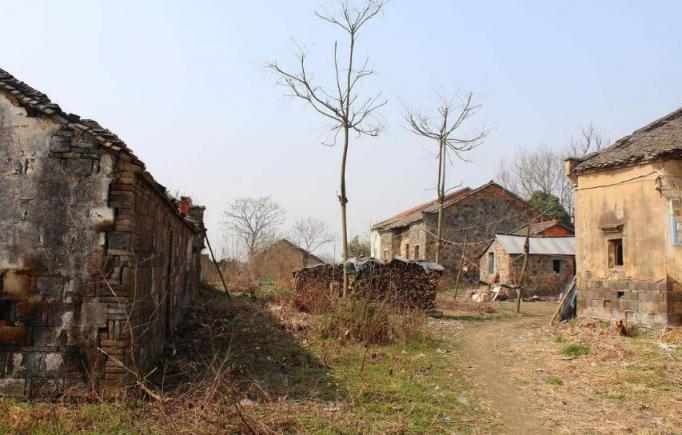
(252, 239, 324, 285)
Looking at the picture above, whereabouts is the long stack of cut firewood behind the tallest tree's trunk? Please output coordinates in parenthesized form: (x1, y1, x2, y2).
(294, 259, 442, 314)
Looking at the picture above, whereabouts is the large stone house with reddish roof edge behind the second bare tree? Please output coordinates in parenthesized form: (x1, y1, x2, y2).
(370, 181, 549, 283)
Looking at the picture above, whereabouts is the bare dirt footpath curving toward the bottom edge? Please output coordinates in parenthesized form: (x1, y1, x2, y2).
(458, 302, 556, 434)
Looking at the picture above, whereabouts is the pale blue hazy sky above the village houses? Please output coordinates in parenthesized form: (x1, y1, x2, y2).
(0, 0, 682, 255)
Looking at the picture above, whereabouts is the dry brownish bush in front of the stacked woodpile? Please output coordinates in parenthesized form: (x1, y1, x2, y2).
(320, 298, 425, 344)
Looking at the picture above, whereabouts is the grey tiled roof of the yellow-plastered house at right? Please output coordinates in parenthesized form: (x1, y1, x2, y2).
(575, 108, 682, 173)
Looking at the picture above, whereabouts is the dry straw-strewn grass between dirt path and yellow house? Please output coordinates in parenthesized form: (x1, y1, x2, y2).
(514, 320, 682, 433)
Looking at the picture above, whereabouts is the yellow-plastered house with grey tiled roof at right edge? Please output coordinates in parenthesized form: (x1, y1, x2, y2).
(566, 109, 682, 327)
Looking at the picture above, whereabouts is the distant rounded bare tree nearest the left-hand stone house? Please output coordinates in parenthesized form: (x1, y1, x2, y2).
(225, 196, 285, 261)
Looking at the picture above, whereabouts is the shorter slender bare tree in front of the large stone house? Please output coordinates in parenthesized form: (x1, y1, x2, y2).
(405, 92, 487, 262)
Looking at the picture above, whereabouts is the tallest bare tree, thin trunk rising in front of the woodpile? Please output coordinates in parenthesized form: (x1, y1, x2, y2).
(268, 0, 386, 297)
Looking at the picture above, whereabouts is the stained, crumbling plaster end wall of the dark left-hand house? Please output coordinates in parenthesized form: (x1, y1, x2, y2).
(0, 95, 114, 395)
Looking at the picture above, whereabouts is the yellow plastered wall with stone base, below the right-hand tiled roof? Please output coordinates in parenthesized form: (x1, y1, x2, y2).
(575, 161, 682, 326)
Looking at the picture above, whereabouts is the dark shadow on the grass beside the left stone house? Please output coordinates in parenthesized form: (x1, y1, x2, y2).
(153, 287, 345, 401)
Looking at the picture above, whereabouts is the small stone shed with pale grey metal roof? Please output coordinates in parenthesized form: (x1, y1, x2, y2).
(479, 234, 575, 296)
